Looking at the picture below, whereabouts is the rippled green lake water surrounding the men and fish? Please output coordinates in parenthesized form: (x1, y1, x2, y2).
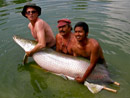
(0, 0, 130, 98)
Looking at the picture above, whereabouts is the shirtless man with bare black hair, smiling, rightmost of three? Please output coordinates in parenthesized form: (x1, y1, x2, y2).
(72, 22, 105, 83)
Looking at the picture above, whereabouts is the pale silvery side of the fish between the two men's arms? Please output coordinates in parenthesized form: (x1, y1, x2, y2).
(33, 49, 88, 77)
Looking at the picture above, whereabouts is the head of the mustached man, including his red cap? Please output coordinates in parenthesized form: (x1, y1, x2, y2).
(57, 18, 72, 36)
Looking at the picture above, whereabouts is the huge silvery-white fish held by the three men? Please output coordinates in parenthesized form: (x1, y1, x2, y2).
(13, 36, 119, 93)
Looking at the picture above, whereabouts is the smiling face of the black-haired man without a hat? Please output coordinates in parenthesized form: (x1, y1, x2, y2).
(74, 27, 86, 41)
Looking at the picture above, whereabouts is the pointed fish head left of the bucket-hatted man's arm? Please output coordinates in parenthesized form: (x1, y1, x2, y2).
(13, 35, 37, 51)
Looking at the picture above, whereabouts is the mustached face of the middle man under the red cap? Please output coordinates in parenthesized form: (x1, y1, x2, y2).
(58, 25, 71, 36)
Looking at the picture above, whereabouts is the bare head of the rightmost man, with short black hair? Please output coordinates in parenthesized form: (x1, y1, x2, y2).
(74, 22, 89, 41)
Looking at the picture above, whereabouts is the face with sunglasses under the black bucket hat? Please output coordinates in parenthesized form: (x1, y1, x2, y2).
(25, 7, 38, 21)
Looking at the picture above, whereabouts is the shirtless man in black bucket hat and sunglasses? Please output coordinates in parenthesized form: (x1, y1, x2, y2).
(21, 3, 55, 56)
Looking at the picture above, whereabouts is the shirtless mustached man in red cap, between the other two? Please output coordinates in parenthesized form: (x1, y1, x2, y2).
(56, 18, 74, 54)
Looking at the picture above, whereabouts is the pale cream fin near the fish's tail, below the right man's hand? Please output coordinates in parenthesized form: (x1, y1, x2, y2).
(84, 81, 104, 94)
